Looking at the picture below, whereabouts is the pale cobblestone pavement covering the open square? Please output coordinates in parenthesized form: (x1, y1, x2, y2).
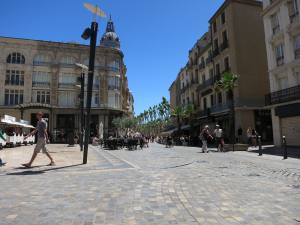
(0, 144, 300, 225)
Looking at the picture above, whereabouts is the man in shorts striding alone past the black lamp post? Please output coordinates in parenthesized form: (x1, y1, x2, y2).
(22, 112, 55, 168)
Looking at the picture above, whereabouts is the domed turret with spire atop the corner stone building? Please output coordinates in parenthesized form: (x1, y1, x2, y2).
(100, 16, 120, 49)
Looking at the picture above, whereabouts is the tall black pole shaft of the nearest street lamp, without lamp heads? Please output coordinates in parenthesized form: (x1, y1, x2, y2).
(83, 22, 98, 164)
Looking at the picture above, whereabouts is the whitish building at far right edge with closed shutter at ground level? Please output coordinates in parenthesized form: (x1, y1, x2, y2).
(263, 0, 300, 146)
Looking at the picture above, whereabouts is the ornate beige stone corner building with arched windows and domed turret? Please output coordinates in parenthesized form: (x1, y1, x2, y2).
(0, 17, 133, 141)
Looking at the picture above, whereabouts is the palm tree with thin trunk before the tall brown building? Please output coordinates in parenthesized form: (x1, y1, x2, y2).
(215, 72, 238, 151)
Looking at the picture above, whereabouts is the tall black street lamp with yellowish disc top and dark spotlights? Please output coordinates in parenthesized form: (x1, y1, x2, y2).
(81, 3, 106, 164)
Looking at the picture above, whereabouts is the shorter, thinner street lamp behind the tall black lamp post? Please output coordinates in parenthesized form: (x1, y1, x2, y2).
(75, 63, 89, 151)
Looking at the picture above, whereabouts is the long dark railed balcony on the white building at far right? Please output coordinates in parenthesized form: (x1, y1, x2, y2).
(265, 85, 300, 105)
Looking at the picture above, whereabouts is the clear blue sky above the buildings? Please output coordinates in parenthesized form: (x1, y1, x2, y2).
(0, 0, 223, 113)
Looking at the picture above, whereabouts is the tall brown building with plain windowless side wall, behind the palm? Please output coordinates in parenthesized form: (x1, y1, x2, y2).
(169, 0, 272, 141)
